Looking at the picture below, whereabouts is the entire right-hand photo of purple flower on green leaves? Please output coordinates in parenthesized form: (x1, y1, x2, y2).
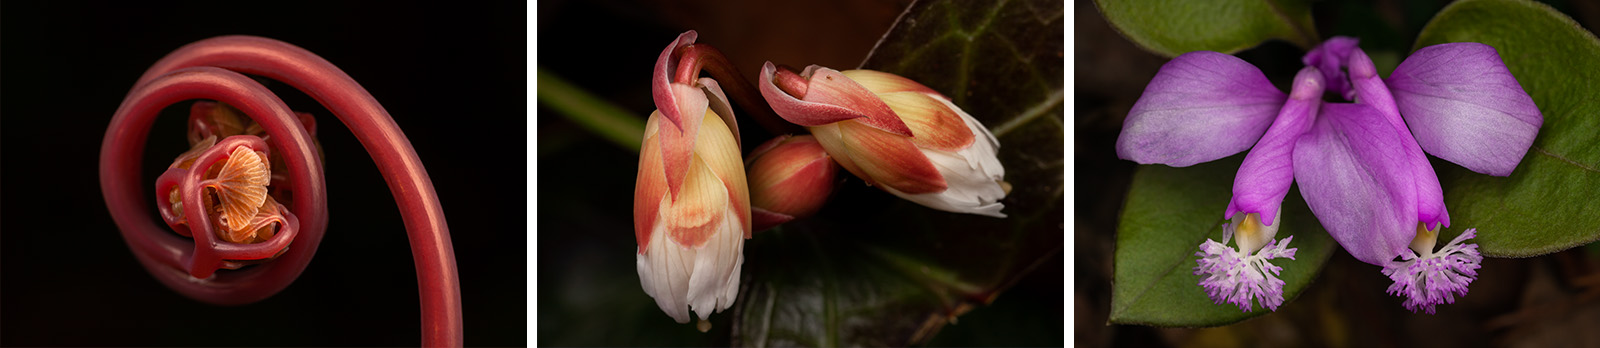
(1077, 0, 1600, 346)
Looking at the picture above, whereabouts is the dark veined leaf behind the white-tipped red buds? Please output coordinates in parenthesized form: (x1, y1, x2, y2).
(731, 0, 1066, 346)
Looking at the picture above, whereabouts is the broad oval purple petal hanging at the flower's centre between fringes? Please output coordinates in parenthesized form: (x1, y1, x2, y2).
(1294, 104, 1416, 265)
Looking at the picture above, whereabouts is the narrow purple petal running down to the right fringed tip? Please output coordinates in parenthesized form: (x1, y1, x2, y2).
(1349, 48, 1450, 228)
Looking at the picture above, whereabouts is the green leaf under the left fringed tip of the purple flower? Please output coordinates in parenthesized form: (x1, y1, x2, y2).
(1110, 155, 1338, 327)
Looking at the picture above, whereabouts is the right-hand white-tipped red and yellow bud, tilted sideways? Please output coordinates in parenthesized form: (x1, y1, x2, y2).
(760, 62, 1006, 217)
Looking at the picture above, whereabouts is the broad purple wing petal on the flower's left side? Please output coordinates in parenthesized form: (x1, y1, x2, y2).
(1117, 51, 1288, 166)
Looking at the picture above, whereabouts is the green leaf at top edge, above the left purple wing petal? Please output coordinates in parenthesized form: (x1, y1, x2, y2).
(1094, 0, 1317, 57)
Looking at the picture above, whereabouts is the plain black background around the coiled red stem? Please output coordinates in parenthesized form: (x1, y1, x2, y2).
(0, 2, 528, 346)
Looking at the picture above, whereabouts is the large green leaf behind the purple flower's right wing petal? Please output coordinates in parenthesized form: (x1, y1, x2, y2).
(1416, 0, 1600, 257)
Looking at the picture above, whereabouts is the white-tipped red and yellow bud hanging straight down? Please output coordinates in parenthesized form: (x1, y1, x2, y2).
(634, 32, 752, 322)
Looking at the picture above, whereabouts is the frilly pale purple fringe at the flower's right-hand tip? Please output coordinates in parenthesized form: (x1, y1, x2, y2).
(1384, 228, 1483, 314)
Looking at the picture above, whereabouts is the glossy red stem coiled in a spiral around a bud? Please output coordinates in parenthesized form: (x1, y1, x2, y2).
(101, 37, 462, 346)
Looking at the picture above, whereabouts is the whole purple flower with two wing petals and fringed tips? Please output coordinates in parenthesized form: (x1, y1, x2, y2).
(1117, 37, 1542, 313)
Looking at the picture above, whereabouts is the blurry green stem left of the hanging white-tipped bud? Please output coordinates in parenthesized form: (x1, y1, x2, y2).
(536, 67, 645, 152)
